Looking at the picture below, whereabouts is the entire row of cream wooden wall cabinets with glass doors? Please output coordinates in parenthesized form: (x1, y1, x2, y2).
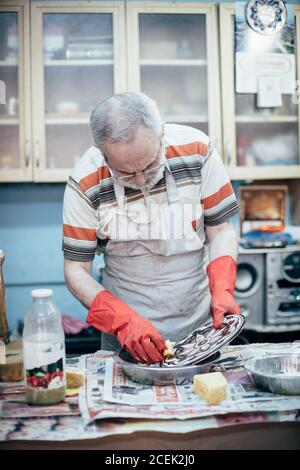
(0, 0, 300, 182)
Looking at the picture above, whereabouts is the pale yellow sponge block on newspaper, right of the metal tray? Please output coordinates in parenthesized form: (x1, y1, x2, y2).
(193, 372, 227, 405)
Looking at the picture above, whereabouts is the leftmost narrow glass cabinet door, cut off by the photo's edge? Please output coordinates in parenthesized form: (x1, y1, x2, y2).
(0, 3, 31, 181)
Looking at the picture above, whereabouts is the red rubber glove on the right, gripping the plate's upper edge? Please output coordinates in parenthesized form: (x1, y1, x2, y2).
(206, 256, 241, 328)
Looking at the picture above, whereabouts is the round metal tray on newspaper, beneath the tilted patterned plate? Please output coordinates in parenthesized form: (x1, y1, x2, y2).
(113, 350, 220, 385)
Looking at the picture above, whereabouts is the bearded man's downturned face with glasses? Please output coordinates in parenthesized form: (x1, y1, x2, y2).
(103, 126, 164, 190)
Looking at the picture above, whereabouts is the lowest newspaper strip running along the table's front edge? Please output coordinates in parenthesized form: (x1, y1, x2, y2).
(0, 410, 300, 445)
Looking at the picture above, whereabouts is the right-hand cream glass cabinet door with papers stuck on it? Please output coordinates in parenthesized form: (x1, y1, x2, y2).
(220, 4, 300, 179)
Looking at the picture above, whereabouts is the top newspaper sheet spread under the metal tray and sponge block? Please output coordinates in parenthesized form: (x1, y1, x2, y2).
(79, 344, 300, 422)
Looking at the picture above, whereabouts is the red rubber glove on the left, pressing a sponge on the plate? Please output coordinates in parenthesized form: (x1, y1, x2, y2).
(86, 290, 166, 364)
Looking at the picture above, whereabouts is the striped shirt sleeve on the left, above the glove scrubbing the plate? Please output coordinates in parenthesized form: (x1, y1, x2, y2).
(62, 177, 98, 261)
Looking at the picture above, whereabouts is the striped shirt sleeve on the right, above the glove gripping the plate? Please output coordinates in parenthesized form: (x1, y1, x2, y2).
(201, 149, 240, 226)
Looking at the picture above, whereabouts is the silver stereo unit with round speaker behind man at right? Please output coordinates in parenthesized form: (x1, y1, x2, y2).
(235, 245, 300, 332)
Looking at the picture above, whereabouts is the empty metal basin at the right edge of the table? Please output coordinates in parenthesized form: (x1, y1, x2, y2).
(245, 353, 300, 395)
